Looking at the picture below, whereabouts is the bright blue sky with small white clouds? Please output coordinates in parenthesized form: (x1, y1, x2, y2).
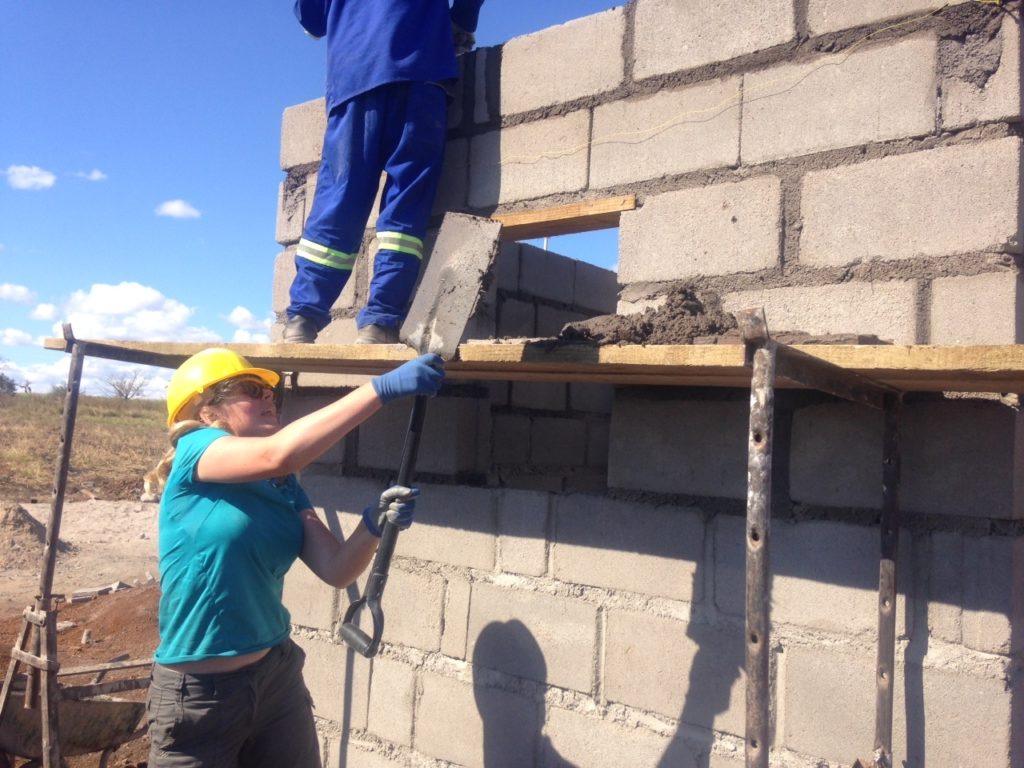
(0, 0, 623, 396)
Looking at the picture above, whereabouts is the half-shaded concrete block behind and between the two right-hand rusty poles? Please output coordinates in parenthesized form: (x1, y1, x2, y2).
(715, 516, 913, 635)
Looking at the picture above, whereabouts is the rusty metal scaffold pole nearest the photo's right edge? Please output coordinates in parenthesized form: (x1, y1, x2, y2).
(874, 394, 903, 768)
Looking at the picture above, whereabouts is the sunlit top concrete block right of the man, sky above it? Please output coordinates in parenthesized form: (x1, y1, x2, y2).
(500, 7, 626, 116)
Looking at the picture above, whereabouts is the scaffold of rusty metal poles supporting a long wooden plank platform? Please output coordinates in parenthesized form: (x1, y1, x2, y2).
(8, 323, 1024, 768)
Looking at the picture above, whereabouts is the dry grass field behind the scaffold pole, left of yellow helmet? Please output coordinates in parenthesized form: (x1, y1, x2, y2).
(0, 394, 168, 503)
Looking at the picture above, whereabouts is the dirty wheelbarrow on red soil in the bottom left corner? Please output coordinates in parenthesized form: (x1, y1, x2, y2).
(0, 683, 145, 768)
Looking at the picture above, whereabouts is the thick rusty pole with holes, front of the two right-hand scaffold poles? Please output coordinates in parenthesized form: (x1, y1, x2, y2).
(737, 312, 776, 768)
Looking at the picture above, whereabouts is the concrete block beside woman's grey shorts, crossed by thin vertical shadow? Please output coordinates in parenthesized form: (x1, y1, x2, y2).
(292, 636, 370, 729)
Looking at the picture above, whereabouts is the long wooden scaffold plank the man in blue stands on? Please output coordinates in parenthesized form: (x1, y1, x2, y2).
(43, 339, 1024, 393)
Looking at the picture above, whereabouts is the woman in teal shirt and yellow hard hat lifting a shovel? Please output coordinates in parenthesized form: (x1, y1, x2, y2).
(147, 348, 443, 768)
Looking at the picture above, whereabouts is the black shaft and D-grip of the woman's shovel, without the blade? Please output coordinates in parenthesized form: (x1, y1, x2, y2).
(341, 394, 427, 658)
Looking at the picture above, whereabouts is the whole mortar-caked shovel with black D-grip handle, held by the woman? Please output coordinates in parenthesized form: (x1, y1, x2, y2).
(341, 213, 502, 658)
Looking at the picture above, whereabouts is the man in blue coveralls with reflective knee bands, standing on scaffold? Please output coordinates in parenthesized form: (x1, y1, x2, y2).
(284, 0, 483, 344)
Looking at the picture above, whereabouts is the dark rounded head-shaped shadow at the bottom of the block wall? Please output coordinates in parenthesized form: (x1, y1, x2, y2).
(472, 618, 577, 768)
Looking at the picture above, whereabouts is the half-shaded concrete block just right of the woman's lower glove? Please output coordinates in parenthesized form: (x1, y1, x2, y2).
(397, 483, 498, 571)
